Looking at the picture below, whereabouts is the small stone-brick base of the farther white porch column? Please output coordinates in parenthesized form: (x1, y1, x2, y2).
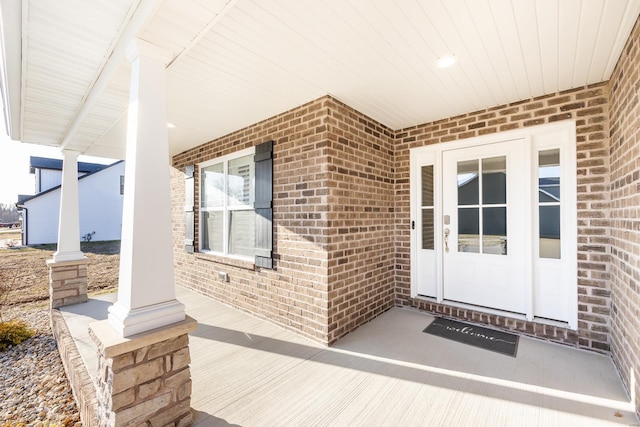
(47, 258, 89, 308)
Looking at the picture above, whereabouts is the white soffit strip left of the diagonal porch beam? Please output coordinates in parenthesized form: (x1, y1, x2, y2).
(22, 0, 138, 145)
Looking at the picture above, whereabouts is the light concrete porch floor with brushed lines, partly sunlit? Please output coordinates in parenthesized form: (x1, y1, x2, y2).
(61, 288, 639, 427)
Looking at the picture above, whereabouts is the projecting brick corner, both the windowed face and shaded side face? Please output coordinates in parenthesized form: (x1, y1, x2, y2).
(172, 97, 395, 343)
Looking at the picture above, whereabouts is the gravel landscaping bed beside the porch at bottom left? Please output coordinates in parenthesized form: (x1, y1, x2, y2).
(0, 303, 82, 427)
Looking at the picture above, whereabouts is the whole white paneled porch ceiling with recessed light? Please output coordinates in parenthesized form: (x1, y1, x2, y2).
(0, 0, 640, 158)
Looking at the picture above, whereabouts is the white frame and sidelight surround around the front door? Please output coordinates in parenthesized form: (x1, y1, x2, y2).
(410, 120, 578, 330)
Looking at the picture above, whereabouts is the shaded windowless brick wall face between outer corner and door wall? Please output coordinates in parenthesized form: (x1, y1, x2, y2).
(327, 99, 395, 342)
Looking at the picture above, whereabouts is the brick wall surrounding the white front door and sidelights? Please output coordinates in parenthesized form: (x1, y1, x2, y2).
(395, 83, 611, 351)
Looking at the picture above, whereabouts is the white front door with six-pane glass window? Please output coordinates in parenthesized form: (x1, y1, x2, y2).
(441, 139, 531, 314)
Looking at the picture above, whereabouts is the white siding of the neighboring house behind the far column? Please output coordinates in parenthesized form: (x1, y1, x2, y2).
(24, 162, 125, 245)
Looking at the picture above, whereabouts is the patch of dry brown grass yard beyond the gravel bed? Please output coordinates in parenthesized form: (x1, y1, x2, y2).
(0, 241, 120, 306)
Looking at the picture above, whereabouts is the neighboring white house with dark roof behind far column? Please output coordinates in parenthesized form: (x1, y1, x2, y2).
(18, 157, 124, 245)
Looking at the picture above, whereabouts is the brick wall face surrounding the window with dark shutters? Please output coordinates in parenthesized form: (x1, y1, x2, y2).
(172, 99, 336, 342)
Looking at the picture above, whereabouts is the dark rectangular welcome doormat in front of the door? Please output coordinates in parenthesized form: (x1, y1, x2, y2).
(422, 317, 520, 357)
